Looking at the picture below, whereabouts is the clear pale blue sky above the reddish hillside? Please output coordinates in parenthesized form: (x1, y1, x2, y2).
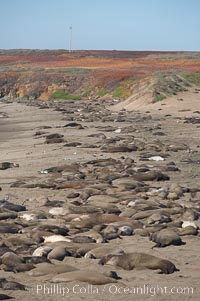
(0, 0, 200, 51)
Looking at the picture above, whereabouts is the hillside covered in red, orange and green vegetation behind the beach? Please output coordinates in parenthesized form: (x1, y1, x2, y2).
(0, 50, 200, 104)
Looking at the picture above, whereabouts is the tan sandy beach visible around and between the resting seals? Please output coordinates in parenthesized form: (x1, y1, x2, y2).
(0, 94, 200, 301)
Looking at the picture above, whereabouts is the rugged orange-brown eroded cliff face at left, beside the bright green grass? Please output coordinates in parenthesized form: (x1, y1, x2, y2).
(0, 72, 97, 100)
